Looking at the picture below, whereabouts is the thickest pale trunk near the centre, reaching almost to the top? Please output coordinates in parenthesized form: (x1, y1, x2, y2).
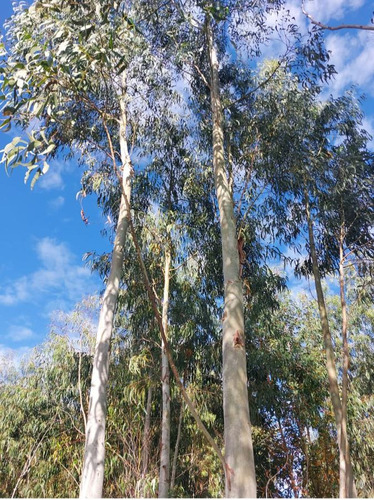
(206, 17, 256, 498)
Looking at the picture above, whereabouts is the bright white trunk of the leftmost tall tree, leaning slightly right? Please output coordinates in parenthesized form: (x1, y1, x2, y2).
(80, 82, 132, 498)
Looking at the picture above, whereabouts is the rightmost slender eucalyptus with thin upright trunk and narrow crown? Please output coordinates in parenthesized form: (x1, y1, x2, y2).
(312, 95, 374, 496)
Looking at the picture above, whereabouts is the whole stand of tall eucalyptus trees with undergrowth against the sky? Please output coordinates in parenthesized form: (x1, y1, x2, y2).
(0, 0, 374, 498)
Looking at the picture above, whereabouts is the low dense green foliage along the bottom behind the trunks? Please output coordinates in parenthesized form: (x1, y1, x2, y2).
(0, 294, 374, 497)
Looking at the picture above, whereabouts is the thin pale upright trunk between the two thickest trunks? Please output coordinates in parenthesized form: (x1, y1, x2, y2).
(158, 248, 171, 498)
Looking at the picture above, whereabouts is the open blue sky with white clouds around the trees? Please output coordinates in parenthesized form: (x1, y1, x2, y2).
(0, 0, 374, 355)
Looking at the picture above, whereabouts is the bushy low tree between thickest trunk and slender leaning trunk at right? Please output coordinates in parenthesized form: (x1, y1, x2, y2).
(248, 294, 337, 498)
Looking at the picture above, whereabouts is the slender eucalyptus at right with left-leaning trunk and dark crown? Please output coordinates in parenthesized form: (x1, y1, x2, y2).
(253, 63, 372, 497)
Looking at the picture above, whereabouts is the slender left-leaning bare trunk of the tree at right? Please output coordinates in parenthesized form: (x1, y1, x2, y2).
(305, 189, 353, 498)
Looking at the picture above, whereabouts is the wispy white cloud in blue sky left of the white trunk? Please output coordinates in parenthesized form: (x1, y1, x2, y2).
(0, 237, 97, 307)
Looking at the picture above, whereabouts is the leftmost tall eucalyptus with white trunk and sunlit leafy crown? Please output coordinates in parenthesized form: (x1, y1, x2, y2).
(2, 0, 172, 497)
